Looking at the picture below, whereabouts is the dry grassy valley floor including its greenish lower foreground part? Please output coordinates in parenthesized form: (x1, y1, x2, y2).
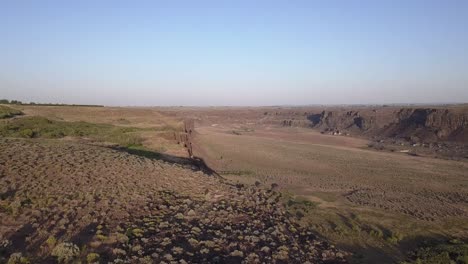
(196, 126, 468, 262)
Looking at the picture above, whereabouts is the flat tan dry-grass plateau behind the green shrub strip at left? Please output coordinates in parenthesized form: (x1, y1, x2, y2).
(4, 105, 188, 157)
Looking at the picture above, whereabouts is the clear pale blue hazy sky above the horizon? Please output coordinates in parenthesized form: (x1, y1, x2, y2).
(0, 0, 468, 105)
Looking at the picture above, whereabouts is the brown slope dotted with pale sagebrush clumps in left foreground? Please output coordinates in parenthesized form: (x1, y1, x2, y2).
(0, 138, 346, 263)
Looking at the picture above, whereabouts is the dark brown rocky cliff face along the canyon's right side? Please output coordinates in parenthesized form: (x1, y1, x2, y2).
(308, 108, 468, 143)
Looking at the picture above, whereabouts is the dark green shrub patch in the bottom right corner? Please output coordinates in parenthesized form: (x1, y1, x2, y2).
(401, 240, 468, 264)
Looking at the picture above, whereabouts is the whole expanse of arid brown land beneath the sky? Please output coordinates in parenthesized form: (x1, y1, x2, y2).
(0, 105, 468, 263)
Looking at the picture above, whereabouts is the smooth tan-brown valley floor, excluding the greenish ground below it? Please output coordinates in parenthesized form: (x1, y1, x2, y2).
(194, 127, 468, 221)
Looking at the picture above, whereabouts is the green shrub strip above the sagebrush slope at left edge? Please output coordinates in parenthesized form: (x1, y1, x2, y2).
(0, 116, 143, 147)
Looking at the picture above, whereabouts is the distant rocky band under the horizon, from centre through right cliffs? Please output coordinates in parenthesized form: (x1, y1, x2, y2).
(156, 105, 468, 143)
